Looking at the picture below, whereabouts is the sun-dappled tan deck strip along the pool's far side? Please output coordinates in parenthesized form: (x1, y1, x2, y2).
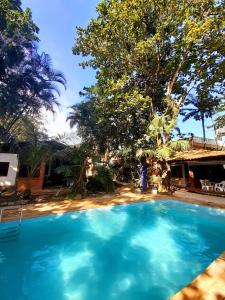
(3, 187, 225, 221)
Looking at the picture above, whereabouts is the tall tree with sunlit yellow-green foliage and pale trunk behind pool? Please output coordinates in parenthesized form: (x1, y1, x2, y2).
(73, 0, 225, 188)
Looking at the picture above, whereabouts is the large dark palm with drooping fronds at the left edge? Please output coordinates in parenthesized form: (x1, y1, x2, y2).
(0, 47, 66, 144)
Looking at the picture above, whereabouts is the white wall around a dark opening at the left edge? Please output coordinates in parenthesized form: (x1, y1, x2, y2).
(0, 153, 18, 187)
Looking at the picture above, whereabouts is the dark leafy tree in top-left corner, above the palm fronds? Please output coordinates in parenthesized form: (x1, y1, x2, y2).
(0, 0, 39, 77)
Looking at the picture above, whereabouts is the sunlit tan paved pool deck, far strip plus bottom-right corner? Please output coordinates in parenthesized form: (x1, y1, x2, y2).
(3, 187, 225, 300)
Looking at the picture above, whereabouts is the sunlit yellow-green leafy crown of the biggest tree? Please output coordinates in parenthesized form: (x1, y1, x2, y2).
(74, 0, 224, 125)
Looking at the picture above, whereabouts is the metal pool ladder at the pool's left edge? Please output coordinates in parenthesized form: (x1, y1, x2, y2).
(0, 205, 23, 243)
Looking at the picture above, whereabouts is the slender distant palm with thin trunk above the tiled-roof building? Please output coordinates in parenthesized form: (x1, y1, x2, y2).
(180, 95, 216, 145)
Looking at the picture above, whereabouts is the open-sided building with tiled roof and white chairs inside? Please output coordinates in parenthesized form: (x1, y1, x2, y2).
(168, 149, 225, 195)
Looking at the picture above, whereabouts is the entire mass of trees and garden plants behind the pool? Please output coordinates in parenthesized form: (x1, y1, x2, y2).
(0, 0, 225, 205)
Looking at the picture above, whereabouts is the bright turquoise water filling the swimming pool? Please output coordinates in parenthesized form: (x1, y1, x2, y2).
(0, 201, 225, 300)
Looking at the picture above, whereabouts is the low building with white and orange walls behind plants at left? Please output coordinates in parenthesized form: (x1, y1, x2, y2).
(0, 140, 65, 192)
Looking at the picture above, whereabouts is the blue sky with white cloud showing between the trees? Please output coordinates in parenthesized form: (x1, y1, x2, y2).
(22, 0, 213, 138)
